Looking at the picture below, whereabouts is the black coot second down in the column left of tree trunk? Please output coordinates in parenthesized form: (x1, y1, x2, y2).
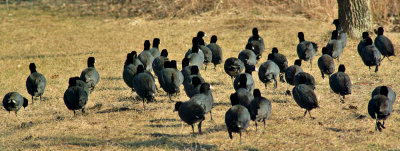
(326, 30, 343, 62)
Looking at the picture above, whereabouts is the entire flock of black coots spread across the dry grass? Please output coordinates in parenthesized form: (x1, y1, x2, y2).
(3, 20, 396, 144)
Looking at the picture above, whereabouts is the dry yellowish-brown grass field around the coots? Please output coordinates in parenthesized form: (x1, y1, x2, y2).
(0, 5, 400, 150)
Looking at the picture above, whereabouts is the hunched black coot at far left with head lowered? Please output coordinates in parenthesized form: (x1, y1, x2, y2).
(3, 92, 28, 116)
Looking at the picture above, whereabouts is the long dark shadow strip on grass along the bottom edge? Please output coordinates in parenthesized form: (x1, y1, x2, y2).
(32, 134, 217, 150)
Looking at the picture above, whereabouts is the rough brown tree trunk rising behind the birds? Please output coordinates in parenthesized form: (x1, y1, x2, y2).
(337, 0, 372, 38)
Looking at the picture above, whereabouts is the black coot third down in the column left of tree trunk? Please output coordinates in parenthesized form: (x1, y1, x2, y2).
(318, 47, 335, 79)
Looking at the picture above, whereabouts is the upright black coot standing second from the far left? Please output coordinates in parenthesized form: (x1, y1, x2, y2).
(26, 63, 47, 103)
